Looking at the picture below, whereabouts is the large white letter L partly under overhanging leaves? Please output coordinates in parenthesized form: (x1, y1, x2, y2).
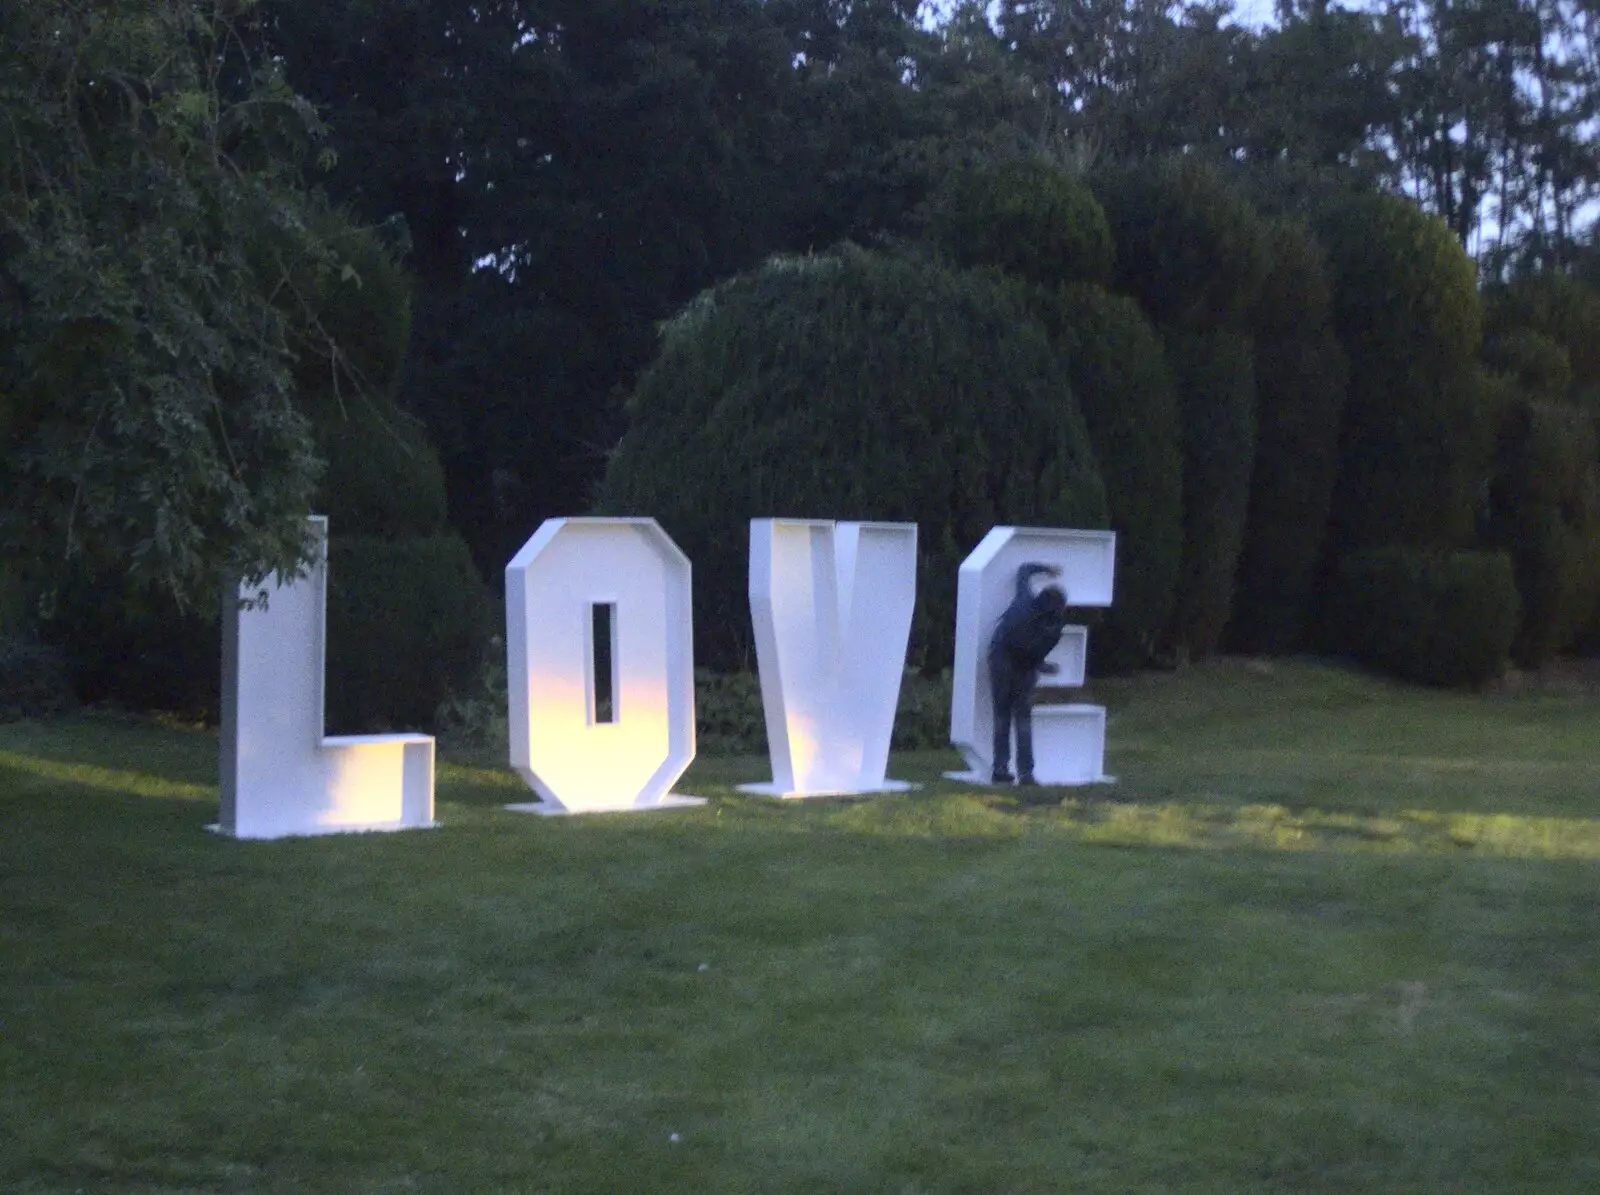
(218, 517, 434, 838)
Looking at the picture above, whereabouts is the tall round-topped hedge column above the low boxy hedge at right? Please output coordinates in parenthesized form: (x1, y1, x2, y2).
(1317, 195, 1490, 557)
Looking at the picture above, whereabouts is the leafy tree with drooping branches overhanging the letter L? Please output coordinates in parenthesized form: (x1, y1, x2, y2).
(0, 0, 338, 606)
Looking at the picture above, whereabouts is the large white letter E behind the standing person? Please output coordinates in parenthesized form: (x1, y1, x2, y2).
(950, 526, 1117, 784)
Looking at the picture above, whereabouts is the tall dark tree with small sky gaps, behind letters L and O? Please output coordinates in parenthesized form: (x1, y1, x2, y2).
(256, 0, 938, 574)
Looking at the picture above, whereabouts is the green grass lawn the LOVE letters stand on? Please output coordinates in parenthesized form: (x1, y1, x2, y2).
(0, 664, 1600, 1195)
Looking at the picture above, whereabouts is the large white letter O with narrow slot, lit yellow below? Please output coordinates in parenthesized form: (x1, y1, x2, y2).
(506, 518, 699, 814)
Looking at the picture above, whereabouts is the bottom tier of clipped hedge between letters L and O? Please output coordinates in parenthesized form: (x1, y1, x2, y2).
(326, 533, 494, 733)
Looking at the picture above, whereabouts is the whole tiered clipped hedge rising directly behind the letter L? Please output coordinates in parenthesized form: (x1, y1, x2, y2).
(298, 230, 494, 733)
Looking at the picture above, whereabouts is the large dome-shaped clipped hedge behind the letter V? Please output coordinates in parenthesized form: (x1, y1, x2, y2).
(598, 250, 1106, 669)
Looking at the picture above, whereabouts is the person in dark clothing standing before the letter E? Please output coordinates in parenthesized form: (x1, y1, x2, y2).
(989, 565, 1067, 784)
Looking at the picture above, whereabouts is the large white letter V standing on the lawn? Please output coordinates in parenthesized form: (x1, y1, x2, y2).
(739, 518, 917, 797)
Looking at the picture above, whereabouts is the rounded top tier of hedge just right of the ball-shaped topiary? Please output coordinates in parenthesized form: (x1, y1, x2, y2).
(1093, 158, 1267, 331)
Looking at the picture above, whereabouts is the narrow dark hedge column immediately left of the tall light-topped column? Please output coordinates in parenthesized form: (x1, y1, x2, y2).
(1224, 222, 1349, 654)
